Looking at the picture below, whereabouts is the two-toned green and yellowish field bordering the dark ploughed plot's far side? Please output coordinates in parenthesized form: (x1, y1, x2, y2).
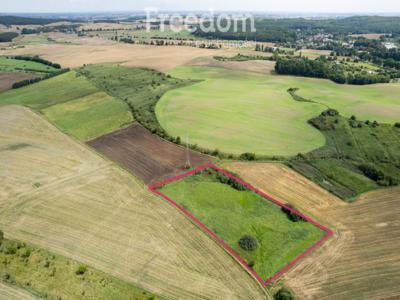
(0, 71, 132, 141)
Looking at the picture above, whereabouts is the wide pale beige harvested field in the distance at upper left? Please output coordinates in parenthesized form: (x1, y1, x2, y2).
(0, 36, 223, 71)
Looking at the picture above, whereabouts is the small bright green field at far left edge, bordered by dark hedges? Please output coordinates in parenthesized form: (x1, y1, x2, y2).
(0, 56, 59, 73)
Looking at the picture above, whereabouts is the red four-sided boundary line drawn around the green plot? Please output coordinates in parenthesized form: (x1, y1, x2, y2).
(149, 164, 333, 286)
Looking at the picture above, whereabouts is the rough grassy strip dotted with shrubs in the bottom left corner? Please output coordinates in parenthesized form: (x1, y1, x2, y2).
(0, 239, 162, 300)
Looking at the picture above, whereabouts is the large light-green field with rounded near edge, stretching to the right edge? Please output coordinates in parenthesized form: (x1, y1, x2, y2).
(156, 67, 400, 156)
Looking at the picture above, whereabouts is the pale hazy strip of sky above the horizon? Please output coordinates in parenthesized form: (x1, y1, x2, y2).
(0, 0, 400, 14)
